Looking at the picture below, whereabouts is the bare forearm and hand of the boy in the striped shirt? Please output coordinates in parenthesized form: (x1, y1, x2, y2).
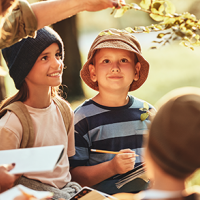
(70, 149, 135, 187)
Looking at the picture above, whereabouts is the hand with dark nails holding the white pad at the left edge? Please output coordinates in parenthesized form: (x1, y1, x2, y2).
(0, 164, 17, 193)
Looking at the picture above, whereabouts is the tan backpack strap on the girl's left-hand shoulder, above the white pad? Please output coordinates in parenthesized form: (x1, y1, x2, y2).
(0, 101, 35, 148)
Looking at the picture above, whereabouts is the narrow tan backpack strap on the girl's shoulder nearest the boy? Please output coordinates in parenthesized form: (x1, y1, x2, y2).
(53, 97, 71, 133)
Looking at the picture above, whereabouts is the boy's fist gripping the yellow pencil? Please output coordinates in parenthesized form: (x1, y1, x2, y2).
(111, 149, 136, 174)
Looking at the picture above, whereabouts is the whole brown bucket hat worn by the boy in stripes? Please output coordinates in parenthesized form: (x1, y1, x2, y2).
(80, 28, 149, 91)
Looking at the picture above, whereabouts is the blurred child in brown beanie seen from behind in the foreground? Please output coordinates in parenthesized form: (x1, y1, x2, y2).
(115, 87, 200, 200)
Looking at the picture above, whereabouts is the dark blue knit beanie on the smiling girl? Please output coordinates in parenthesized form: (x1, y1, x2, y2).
(2, 26, 64, 89)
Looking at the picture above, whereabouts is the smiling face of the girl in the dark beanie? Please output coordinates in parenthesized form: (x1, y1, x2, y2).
(25, 43, 63, 89)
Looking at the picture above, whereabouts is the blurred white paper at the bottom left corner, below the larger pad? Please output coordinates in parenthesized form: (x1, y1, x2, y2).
(0, 185, 53, 200)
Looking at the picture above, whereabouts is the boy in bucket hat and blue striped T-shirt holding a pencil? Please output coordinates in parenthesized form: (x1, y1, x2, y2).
(70, 29, 155, 194)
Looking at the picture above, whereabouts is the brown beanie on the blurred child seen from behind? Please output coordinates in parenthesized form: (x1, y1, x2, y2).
(145, 87, 200, 181)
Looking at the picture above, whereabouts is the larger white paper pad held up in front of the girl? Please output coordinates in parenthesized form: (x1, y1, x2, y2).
(0, 145, 64, 174)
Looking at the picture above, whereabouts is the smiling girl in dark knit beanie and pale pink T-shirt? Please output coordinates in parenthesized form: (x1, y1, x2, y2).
(0, 27, 81, 199)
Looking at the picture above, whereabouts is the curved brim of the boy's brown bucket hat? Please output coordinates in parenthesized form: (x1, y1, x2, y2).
(80, 40, 149, 91)
